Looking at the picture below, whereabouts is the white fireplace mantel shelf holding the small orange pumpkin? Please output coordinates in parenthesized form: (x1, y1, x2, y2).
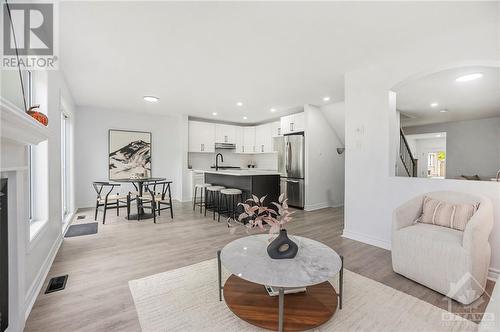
(0, 98, 49, 145)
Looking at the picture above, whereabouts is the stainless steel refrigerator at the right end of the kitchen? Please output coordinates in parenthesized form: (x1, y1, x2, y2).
(274, 133, 305, 208)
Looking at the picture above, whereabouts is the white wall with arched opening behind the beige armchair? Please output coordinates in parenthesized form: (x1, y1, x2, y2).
(344, 9, 500, 278)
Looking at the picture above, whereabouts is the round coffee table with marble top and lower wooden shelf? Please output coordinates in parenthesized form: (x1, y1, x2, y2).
(217, 234, 343, 331)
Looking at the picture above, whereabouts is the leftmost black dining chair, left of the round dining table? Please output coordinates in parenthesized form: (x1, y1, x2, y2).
(92, 181, 130, 224)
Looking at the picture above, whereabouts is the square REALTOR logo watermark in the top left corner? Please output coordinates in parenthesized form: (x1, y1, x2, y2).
(0, 1, 59, 70)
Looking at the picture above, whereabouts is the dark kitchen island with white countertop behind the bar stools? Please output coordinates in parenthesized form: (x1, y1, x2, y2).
(203, 169, 280, 206)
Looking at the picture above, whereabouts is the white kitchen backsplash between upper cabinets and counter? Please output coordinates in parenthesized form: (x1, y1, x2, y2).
(188, 150, 278, 170)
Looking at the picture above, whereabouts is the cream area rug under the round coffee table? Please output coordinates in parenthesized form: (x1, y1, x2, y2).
(129, 259, 477, 332)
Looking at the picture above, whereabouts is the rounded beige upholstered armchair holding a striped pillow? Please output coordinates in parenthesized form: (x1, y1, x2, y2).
(392, 191, 493, 304)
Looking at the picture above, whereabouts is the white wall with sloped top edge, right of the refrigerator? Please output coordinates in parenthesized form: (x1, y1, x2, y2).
(304, 105, 344, 211)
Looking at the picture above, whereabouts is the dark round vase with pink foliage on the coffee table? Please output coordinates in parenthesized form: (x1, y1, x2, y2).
(230, 194, 299, 259)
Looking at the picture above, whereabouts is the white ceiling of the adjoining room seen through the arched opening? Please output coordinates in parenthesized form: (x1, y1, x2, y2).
(395, 67, 500, 126)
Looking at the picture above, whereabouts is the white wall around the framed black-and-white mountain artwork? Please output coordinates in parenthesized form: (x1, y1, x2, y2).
(75, 108, 184, 208)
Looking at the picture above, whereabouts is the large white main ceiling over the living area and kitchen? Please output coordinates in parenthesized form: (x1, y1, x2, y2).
(60, 2, 498, 122)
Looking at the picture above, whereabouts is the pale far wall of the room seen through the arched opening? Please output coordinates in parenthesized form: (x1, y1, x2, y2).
(404, 117, 500, 179)
